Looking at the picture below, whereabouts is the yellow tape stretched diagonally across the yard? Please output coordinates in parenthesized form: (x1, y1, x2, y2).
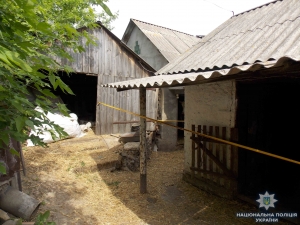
(97, 102, 300, 165)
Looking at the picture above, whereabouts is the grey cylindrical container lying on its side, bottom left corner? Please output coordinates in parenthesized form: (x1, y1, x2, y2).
(0, 186, 40, 220)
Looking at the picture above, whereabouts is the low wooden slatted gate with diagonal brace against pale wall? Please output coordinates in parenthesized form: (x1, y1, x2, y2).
(190, 125, 238, 194)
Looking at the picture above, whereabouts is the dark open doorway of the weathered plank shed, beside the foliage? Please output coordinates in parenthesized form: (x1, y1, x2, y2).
(55, 73, 98, 124)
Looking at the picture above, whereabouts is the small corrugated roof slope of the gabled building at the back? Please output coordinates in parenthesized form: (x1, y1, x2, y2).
(131, 19, 201, 62)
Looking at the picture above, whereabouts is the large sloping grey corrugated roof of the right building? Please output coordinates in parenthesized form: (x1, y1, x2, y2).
(156, 0, 300, 75)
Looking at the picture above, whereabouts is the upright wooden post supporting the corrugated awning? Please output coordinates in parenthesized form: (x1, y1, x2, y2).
(140, 88, 147, 194)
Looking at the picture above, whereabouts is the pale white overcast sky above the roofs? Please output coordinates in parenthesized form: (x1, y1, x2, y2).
(106, 0, 272, 39)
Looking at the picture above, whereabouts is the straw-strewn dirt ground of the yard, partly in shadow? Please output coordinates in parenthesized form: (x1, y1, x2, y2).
(22, 130, 292, 225)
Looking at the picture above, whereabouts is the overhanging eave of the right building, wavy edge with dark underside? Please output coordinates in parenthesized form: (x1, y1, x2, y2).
(102, 56, 300, 91)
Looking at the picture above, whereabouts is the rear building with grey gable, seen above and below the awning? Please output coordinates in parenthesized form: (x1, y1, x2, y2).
(122, 19, 201, 151)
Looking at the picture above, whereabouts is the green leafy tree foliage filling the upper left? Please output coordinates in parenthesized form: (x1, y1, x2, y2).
(0, 0, 113, 173)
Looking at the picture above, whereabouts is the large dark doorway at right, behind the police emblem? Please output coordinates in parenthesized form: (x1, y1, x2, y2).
(237, 78, 300, 215)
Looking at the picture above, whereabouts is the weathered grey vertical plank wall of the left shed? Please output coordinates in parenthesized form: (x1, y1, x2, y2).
(58, 28, 158, 135)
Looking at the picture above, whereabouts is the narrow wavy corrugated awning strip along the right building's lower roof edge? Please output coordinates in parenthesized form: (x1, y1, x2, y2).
(102, 57, 297, 90)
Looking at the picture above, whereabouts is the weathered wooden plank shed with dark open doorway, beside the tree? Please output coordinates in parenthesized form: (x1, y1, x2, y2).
(57, 23, 158, 135)
